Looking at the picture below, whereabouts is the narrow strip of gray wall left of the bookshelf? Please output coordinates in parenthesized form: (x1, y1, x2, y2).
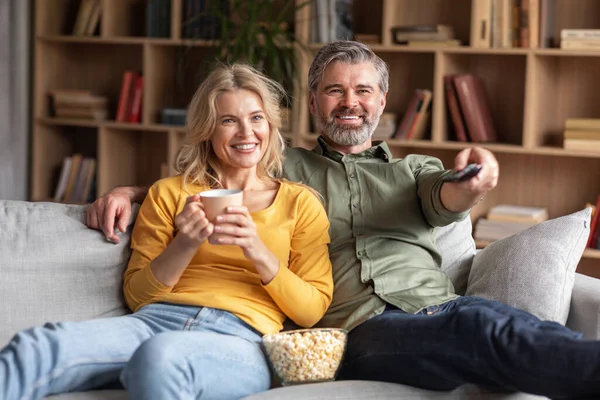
(0, 0, 31, 200)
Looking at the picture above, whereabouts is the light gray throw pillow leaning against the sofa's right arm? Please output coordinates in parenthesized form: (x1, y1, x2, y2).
(466, 208, 592, 325)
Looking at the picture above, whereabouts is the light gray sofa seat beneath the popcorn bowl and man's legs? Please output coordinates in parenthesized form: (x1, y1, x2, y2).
(244, 381, 546, 400)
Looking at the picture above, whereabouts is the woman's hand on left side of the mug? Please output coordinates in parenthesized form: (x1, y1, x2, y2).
(175, 194, 214, 248)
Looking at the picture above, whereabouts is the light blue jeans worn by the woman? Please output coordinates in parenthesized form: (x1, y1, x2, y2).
(0, 304, 271, 400)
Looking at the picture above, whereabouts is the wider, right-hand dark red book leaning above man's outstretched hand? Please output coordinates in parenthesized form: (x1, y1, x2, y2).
(452, 74, 498, 142)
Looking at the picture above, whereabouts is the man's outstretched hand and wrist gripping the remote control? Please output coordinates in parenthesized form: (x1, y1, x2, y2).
(441, 147, 500, 212)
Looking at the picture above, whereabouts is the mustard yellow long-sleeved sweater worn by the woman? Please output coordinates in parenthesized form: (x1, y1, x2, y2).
(124, 176, 333, 333)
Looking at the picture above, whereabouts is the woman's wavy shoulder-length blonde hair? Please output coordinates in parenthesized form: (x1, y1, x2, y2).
(175, 63, 285, 188)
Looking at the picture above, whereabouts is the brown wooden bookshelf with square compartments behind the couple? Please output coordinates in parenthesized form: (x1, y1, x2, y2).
(30, 0, 600, 276)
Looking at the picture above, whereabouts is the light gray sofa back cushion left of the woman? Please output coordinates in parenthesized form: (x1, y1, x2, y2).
(0, 201, 135, 347)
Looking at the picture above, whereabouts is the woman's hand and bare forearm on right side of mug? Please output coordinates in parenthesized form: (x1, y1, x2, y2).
(211, 206, 279, 284)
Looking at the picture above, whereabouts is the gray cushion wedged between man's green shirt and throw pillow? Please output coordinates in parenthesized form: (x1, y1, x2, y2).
(435, 217, 476, 295)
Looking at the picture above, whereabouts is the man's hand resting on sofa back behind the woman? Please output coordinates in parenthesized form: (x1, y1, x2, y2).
(86, 186, 148, 243)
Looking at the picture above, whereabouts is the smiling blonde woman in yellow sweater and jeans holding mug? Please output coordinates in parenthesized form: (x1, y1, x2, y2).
(0, 65, 333, 400)
